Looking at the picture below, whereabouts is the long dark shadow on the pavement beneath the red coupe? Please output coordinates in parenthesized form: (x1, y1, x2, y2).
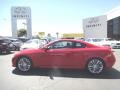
(12, 68, 120, 80)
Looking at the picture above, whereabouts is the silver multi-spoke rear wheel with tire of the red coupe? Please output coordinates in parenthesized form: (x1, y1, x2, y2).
(87, 58, 104, 74)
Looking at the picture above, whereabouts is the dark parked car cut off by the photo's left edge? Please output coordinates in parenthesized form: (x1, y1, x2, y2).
(0, 38, 10, 54)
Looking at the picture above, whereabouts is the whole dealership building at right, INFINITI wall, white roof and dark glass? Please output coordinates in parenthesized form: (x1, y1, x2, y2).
(83, 7, 120, 40)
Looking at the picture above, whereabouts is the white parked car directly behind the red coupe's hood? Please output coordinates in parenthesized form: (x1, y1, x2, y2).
(20, 39, 48, 50)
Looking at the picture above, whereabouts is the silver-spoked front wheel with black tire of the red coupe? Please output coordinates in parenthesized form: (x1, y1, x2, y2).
(17, 56, 32, 72)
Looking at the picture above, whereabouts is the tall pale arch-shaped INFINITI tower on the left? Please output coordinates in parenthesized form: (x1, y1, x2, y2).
(11, 7, 32, 38)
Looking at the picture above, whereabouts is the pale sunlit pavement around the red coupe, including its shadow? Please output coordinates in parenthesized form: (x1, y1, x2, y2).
(0, 49, 120, 90)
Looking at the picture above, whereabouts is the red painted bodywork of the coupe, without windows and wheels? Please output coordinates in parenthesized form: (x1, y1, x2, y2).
(12, 39, 115, 69)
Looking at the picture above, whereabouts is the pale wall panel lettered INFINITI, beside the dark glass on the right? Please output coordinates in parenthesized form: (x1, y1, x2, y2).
(83, 15, 107, 38)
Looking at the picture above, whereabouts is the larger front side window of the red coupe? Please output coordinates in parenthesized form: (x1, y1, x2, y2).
(48, 41, 73, 49)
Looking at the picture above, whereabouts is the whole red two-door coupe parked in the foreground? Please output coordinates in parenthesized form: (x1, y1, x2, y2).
(12, 39, 115, 74)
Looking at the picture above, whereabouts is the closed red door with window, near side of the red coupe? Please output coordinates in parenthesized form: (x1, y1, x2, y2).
(46, 41, 72, 68)
